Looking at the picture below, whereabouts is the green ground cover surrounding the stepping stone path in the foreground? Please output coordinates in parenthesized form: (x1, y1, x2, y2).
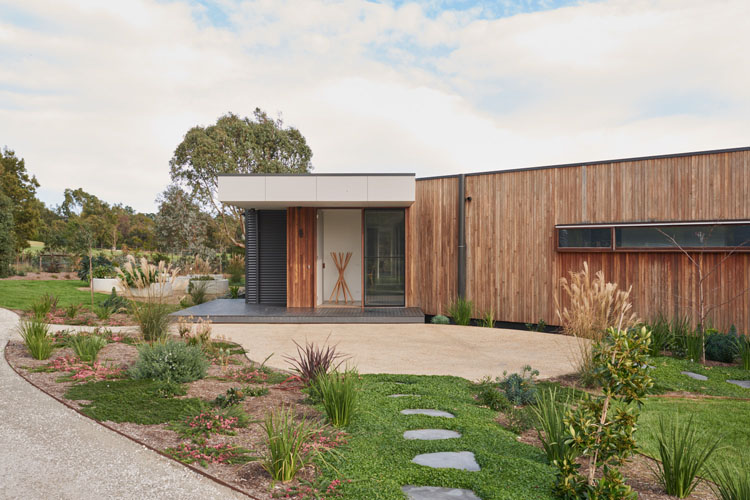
(314, 375, 554, 500)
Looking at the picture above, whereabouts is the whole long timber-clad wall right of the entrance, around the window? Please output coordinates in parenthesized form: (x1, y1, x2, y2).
(409, 151, 750, 332)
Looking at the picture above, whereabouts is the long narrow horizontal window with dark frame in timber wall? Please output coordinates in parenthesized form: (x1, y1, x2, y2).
(556, 221, 750, 252)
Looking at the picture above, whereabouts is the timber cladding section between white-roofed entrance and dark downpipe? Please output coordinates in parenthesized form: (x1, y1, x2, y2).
(406, 177, 458, 314)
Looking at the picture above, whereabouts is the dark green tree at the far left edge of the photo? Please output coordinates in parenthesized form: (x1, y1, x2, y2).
(0, 147, 41, 252)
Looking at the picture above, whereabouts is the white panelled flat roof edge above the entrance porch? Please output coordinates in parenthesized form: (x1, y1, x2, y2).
(219, 174, 416, 209)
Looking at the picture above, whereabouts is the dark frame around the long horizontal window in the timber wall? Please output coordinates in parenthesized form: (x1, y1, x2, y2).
(555, 219, 750, 253)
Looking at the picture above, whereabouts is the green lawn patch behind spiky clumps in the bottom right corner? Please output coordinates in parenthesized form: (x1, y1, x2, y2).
(636, 398, 750, 466)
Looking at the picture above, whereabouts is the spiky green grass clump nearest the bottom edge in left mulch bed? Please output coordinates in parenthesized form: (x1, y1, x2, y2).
(261, 408, 314, 482)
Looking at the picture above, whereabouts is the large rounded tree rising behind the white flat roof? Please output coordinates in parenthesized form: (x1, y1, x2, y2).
(169, 108, 312, 248)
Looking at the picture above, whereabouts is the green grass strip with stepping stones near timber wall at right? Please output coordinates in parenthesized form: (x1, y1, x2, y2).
(650, 357, 750, 399)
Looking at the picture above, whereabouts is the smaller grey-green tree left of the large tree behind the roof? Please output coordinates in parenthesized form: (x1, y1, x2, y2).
(155, 184, 211, 254)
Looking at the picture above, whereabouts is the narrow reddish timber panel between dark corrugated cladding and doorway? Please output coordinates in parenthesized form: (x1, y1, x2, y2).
(286, 207, 317, 307)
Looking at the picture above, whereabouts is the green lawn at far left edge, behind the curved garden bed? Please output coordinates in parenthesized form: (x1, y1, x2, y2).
(0, 280, 107, 311)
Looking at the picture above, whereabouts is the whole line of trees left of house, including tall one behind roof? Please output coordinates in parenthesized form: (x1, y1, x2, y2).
(0, 108, 312, 277)
